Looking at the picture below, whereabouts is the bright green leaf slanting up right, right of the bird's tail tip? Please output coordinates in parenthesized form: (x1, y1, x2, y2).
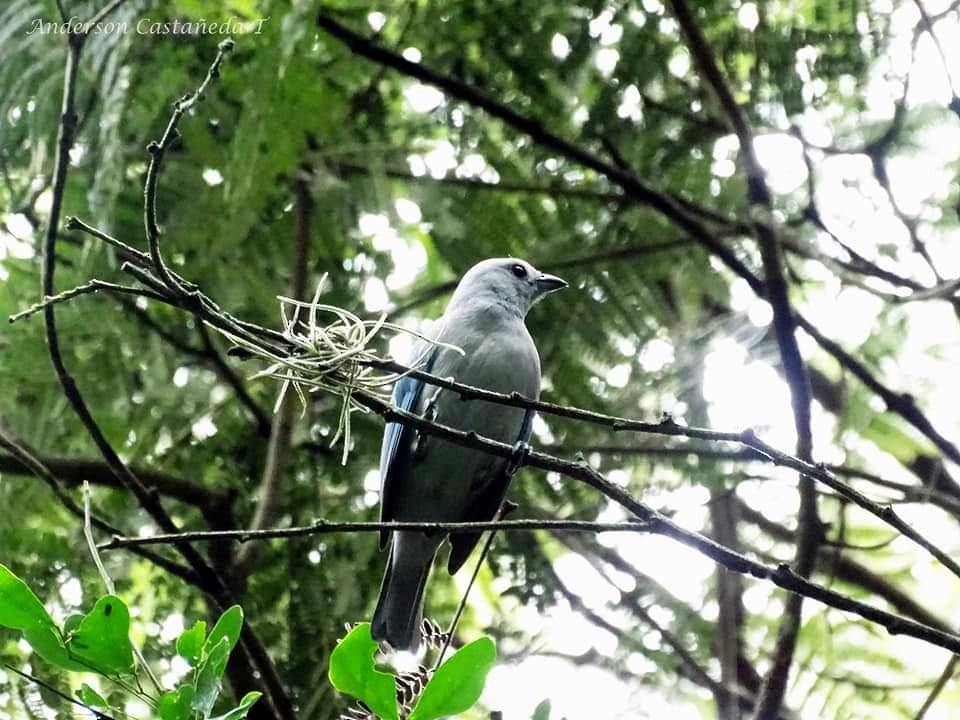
(409, 637, 497, 720)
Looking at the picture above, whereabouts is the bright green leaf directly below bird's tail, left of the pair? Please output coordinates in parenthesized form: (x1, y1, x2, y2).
(328, 623, 399, 720)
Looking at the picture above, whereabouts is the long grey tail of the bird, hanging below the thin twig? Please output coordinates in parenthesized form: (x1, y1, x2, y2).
(370, 532, 440, 652)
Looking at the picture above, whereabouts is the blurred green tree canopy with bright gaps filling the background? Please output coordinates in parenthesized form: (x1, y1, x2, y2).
(0, 0, 960, 720)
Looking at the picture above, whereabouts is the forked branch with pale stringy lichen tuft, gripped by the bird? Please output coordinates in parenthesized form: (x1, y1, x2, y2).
(16, 15, 960, 696)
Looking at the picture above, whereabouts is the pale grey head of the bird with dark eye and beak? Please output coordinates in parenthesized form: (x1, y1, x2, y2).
(450, 258, 567, 317)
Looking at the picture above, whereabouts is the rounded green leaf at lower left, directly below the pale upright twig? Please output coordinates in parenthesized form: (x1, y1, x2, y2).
(67, 595, 133, 675)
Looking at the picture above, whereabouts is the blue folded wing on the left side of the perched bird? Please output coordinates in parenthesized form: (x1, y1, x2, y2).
(380, 340, 438, 549)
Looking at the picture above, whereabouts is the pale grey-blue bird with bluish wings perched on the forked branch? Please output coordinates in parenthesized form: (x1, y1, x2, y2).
(371, 258, 567, 651)
